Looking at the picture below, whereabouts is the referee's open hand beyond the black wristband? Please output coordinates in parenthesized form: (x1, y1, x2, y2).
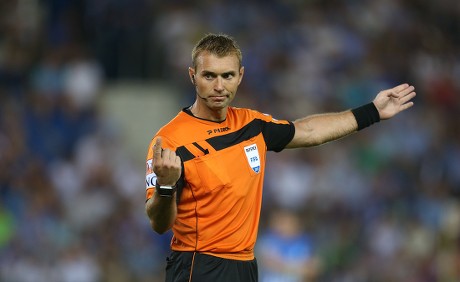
(373, 83, 416, 120)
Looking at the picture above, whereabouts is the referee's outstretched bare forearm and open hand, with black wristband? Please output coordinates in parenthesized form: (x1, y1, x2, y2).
(287, 84, 415, 148)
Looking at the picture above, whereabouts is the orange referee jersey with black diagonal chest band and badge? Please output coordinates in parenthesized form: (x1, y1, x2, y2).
(146, 107, 295, 260)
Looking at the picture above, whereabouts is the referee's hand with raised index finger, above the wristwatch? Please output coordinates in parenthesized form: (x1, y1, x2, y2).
(152, 137, 182, 186)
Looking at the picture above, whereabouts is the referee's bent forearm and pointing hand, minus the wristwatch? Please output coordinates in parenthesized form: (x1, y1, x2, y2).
(145, 137, 182, 234)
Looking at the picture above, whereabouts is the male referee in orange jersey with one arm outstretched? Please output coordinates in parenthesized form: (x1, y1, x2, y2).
(145, 34, 415, 282)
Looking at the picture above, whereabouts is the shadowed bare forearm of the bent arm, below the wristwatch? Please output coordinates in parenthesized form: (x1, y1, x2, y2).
(145, 193, 177, 234)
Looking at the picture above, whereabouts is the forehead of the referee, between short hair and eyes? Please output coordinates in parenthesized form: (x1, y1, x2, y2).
(196, 52, 240, 73)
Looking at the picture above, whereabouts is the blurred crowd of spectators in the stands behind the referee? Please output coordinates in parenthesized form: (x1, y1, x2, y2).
(0, 0, 460, 282)
